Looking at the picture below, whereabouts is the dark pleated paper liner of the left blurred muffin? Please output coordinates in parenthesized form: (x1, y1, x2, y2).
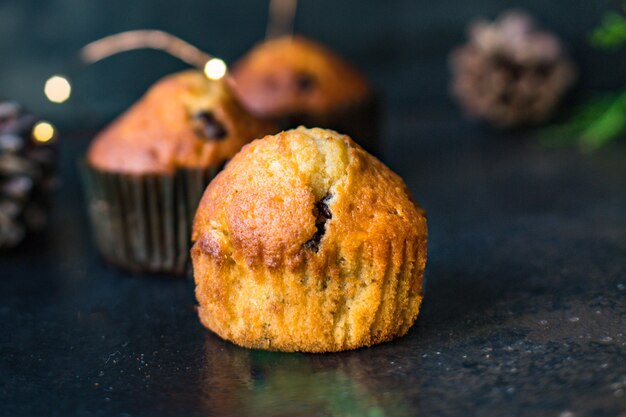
(80, 161, 222, 275)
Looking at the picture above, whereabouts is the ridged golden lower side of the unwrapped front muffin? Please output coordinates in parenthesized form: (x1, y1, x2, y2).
(194, 237, 422, 352)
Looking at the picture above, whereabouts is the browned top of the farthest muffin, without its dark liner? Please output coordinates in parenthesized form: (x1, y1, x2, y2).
(231, 36, 371, 118)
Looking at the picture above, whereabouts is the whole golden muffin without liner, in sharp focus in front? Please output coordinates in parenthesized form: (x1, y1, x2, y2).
(192, 127, 426, 352)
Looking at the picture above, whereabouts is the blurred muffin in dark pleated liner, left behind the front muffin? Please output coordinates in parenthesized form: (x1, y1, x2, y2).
(83, 71, 274, 273)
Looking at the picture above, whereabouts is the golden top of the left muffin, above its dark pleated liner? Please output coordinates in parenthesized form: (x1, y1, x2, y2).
(87, 70, 274, 174)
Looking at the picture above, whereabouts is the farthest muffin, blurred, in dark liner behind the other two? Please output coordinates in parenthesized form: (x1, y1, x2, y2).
(231, 36, 378, 152)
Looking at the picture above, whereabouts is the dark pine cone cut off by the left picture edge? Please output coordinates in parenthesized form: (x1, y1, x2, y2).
(0, 101, 56, 249)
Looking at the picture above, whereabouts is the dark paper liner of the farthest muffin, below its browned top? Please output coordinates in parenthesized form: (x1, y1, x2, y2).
(276, 95, 380, 155)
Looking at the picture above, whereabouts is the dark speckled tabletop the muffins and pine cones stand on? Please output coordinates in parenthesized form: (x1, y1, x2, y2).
(0, 108, 626, 417)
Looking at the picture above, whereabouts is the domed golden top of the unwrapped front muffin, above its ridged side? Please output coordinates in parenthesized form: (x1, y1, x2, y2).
(193, 127, 426, 270)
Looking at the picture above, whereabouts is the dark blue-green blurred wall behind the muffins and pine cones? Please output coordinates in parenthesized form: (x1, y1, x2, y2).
(0, 0, 626, 127)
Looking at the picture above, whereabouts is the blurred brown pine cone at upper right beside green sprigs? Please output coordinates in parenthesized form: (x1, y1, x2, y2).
(450, 12, 576, 127)
